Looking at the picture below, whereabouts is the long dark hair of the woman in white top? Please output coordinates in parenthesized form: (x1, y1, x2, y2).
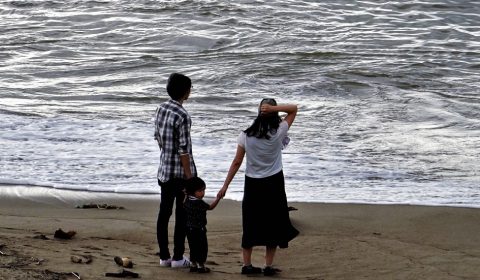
(244, 98, 282, 140)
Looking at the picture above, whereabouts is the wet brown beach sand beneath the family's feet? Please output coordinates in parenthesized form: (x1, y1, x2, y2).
(0, 186, 480, 280)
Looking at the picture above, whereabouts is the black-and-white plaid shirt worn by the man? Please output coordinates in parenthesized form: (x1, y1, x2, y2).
(155, 99, 197, 182)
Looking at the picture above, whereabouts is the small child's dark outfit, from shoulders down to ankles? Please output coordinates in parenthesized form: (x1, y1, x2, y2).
(184, 195, 210, 267)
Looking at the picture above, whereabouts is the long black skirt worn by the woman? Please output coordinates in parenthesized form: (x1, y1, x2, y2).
(242, 171, 299, 248)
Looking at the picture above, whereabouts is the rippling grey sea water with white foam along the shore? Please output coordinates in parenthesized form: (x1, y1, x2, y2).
(0, 0, 480, 207)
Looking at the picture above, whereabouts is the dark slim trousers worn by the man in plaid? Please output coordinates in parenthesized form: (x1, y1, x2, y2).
(157, 179, 186, 260)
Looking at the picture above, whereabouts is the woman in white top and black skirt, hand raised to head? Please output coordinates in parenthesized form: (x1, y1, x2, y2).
(218, 99, 298, 276)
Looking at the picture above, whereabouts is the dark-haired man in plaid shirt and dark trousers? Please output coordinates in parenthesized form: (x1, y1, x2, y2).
(155, 73, 197, 267)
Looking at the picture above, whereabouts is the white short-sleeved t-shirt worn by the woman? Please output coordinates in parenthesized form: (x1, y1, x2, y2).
(237, 121, 288, 178)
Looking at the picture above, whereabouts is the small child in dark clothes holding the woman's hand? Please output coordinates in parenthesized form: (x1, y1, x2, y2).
(184, 177, 220, 273)
